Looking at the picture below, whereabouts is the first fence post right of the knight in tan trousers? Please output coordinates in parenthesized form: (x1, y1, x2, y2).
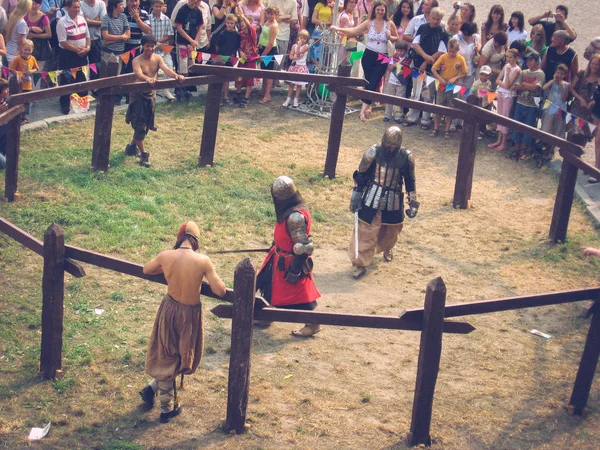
(452, 94, 479, 209)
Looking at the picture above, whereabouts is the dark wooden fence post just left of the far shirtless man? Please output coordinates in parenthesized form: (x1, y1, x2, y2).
(92, 57, 119, 172)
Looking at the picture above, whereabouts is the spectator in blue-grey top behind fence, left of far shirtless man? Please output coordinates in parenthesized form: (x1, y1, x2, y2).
(100, 0, 131, 73)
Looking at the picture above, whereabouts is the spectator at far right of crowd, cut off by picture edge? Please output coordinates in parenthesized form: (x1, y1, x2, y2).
(567, 54, 600, 183)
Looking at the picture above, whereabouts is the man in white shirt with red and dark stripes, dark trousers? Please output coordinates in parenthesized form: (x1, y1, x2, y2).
(56, 0, 90, 114)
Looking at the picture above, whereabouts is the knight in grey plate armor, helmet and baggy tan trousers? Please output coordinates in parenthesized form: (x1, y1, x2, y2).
(348, 126, 419, 278)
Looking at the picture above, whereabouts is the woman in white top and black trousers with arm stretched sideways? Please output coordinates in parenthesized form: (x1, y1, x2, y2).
(331, 1, 400, 122)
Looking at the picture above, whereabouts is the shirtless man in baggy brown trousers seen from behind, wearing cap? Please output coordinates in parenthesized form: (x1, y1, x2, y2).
(140, 222, 226, 423)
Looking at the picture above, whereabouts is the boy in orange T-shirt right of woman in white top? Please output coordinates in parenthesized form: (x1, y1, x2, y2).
(429, 39, 467, 139)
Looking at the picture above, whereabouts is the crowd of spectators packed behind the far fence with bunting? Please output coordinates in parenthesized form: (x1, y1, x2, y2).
(0, 0, 600, 172)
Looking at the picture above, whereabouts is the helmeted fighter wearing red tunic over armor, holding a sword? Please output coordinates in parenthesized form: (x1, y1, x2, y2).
(256, 176, 321, 337)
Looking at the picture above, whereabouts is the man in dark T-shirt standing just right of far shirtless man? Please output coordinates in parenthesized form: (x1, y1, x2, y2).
(175, 0, 204, 100)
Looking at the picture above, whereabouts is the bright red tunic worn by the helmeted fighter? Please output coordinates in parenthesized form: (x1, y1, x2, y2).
(260, 209, 321, 306)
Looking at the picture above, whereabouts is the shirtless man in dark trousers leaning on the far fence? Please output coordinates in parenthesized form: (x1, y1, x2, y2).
(125, 35, 185, 167)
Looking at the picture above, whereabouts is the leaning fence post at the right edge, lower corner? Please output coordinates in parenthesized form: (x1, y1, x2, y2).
(569, 300, 600, 415)
